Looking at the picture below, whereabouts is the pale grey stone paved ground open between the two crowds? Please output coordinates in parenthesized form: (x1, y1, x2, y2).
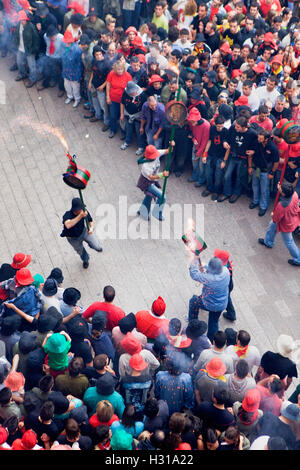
(0, 59, 300, 392)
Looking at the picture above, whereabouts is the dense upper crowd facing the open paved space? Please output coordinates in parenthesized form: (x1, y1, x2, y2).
(0, 0, 300, 216)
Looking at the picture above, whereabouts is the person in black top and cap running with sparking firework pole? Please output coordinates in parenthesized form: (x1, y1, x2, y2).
(60, 198, 102, 269)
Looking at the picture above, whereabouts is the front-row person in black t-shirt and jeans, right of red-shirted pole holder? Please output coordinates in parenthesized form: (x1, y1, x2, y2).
(202, 116, 228, 201)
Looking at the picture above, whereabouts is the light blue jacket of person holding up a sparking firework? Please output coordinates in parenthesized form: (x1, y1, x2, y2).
(190, 259, 230, 312)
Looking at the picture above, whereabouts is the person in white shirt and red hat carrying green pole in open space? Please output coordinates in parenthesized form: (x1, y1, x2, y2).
(137, 141, 175, 221)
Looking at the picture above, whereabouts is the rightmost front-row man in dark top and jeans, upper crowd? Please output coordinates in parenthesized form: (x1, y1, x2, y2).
(249, 128, 279, 217)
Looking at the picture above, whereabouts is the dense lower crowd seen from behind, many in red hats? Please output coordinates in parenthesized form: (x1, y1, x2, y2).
(0, 250, 300, 453)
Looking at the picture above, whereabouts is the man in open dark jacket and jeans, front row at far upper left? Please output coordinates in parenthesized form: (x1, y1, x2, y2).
(14, 10, 40, 88)
